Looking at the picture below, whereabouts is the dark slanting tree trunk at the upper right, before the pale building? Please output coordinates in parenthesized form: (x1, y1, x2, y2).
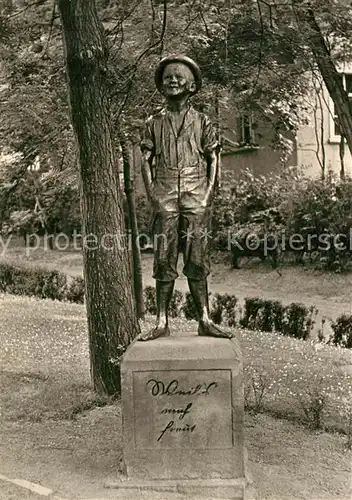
(299, 8, 352, 154)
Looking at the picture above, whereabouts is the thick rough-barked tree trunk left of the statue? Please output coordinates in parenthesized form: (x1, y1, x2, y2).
(58, 0, 139, 395)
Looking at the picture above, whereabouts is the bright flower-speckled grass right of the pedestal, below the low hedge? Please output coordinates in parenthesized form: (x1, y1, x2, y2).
(240, 331, 352, 432)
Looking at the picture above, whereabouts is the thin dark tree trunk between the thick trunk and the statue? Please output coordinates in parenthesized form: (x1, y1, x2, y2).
(120, 134, 145, 319)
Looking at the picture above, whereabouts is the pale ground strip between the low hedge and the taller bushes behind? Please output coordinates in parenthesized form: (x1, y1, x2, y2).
(0, 238, 352, 328)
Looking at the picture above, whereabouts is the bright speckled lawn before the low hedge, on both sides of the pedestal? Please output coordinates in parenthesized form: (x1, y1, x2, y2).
(0, 295, 352, 432)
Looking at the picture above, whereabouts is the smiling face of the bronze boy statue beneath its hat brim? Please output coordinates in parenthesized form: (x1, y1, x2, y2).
(163, 63, 196, 97)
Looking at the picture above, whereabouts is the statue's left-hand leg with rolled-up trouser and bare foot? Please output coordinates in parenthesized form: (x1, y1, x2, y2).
(138, 212, 179, 341)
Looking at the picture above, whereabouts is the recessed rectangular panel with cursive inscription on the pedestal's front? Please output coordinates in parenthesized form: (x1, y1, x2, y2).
(133, 369, 233, 450)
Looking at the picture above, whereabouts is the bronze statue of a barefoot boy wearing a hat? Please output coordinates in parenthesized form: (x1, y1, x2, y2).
(139, 55, 234, 341)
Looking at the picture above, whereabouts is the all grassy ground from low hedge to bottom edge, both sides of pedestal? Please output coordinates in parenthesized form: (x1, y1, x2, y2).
(0, 295, 351, 500)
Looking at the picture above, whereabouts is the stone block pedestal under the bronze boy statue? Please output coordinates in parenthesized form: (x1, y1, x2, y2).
(117, 335, 244, 499)
